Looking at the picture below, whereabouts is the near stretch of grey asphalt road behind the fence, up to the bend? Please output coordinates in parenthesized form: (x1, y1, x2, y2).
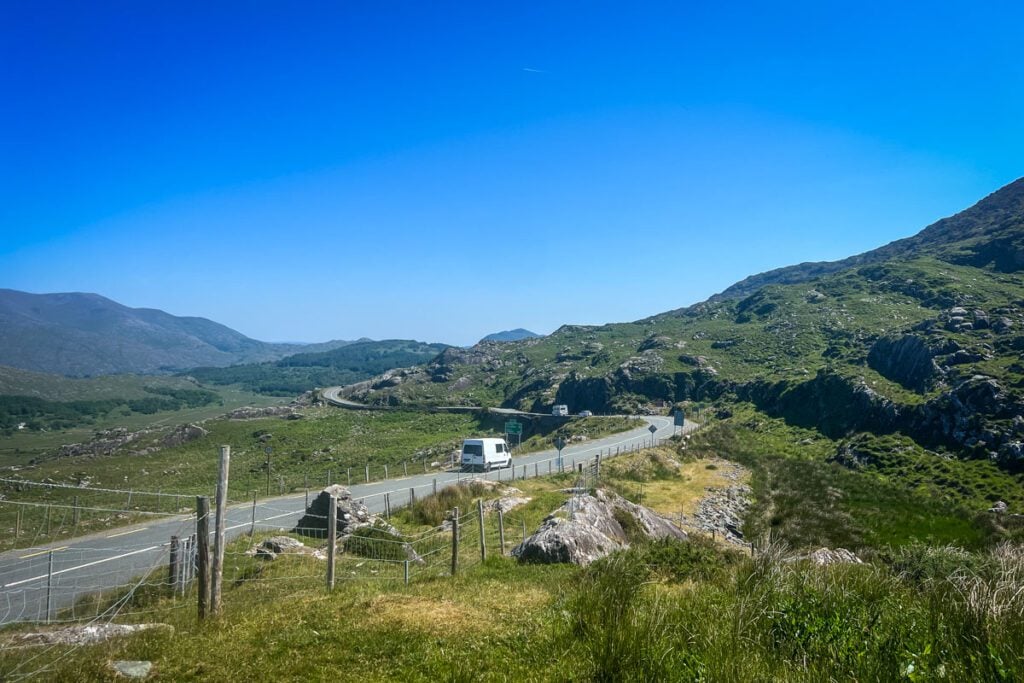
(0, 417, 696, 625)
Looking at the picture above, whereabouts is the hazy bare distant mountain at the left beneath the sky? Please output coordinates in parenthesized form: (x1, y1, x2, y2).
(0, 289, 348, 377)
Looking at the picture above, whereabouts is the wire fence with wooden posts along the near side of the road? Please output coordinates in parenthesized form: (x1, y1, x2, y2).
(0, 421, 704, 680)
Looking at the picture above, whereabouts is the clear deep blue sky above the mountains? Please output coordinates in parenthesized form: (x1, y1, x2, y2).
(0, 0, 1024, 343)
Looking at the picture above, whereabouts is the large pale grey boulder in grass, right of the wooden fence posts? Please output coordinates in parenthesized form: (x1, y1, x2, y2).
(512, 488, 687, 565)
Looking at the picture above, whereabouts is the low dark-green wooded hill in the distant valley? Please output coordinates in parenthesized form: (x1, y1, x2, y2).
(187, 339, 447, 395)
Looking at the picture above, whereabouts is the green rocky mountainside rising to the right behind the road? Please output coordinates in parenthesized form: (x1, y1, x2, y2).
(355, 180, 1024, 463)
